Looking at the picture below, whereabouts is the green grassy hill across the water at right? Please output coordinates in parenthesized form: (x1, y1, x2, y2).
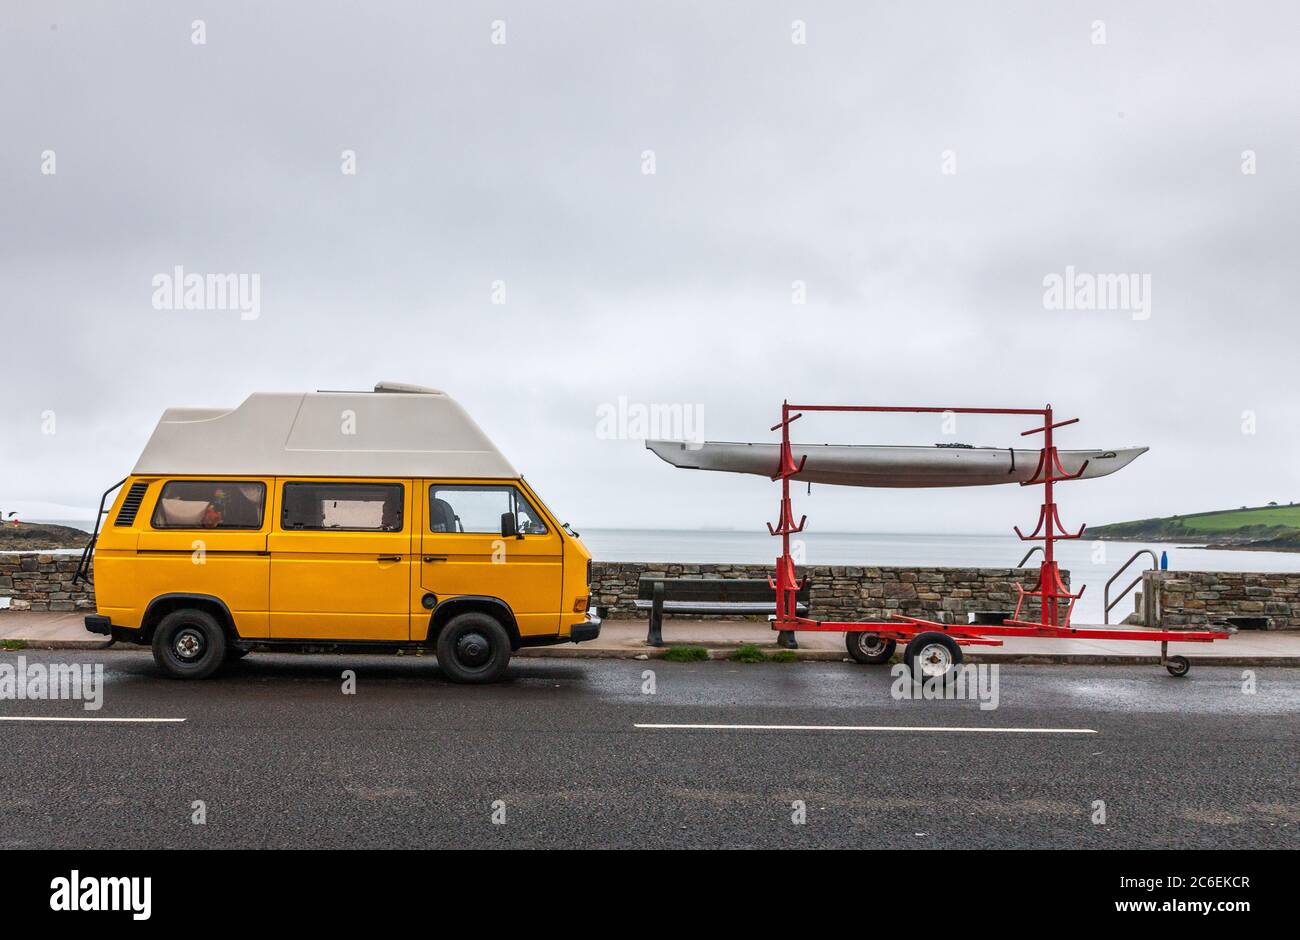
(1088, 504, 1300, 551)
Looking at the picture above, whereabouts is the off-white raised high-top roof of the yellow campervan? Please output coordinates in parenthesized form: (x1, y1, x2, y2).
(134, 382, 519, 477)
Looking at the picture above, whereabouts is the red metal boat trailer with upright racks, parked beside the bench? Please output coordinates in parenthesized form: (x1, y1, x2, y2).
(767, 400, 1231, 676)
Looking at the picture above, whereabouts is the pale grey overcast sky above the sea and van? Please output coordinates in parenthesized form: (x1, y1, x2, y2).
(0, 0, 1300, 532)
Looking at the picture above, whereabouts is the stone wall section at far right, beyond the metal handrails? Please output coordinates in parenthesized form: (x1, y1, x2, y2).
(1143, 571, 1300, 629)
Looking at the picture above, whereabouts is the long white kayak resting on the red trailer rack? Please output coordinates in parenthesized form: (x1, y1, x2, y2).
(646, 441, 1148, 486)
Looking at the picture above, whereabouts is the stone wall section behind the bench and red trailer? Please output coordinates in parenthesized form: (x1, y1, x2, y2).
(592, 562, 1070, 623)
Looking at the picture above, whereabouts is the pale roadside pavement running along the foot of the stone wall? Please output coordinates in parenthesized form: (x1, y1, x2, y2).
(0, 610, 1300, 666)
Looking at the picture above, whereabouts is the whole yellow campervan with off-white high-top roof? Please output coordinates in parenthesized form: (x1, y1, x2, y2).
(86, 384, 601, 683)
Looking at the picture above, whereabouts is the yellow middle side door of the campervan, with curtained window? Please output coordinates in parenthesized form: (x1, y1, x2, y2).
(269, 480, 415, 640)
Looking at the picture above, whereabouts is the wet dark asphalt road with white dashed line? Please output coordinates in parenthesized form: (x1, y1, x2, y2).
(0, 650, 1300, 849)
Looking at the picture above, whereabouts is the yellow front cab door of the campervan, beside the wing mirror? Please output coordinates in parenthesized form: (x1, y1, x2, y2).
(420, 481, 564, 636)
